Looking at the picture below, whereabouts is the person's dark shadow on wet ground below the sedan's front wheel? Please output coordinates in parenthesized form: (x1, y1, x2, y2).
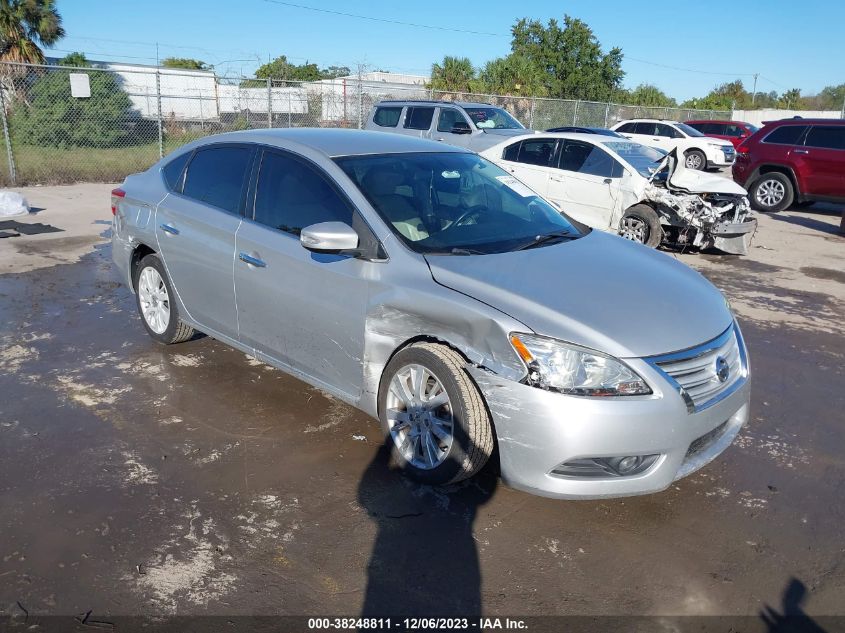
(358, 437, 498, 618)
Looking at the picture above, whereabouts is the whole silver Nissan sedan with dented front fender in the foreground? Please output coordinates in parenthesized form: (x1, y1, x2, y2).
(112, 129, 749, 498)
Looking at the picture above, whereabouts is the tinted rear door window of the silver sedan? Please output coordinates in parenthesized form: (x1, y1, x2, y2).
(182, 146, 252, 214)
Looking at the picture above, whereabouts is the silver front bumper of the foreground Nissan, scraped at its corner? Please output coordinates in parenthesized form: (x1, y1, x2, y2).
(469, 328, 750, 499)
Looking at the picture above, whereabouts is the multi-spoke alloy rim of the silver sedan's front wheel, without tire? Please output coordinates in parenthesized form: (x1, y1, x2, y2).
(386, 364, 454, 470)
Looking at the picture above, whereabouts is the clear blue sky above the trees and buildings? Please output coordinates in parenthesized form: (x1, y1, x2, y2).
(56, 0, 845, 101)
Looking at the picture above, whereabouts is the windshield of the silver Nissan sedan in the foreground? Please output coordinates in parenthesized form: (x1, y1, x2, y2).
(335, 152, 585, 255)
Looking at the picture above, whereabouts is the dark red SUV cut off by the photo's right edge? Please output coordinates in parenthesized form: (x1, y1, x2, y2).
(733, 118, 845, 212)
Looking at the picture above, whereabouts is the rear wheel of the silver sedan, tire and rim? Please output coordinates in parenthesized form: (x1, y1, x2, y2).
(134, 255, 194, 345)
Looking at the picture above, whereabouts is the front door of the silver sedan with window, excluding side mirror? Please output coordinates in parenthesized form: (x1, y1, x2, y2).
(235, 149, 375, 398)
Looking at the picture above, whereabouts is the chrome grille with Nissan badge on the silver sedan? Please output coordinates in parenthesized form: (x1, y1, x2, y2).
(649, 326, 746, 411)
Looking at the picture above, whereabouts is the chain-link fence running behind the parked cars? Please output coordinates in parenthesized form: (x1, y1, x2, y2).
(0, 63, 729, 186)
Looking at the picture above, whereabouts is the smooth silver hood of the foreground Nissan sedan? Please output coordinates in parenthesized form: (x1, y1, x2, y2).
(426, 231, 732, 358)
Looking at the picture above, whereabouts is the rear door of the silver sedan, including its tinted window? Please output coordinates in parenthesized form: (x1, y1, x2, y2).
(156, 145, 254, 339)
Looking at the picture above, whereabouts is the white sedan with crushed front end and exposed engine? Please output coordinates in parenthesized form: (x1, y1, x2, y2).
(482, 133, 757, 255)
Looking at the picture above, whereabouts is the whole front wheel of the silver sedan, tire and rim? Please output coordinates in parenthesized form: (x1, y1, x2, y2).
(378, 343, 494, 485)
